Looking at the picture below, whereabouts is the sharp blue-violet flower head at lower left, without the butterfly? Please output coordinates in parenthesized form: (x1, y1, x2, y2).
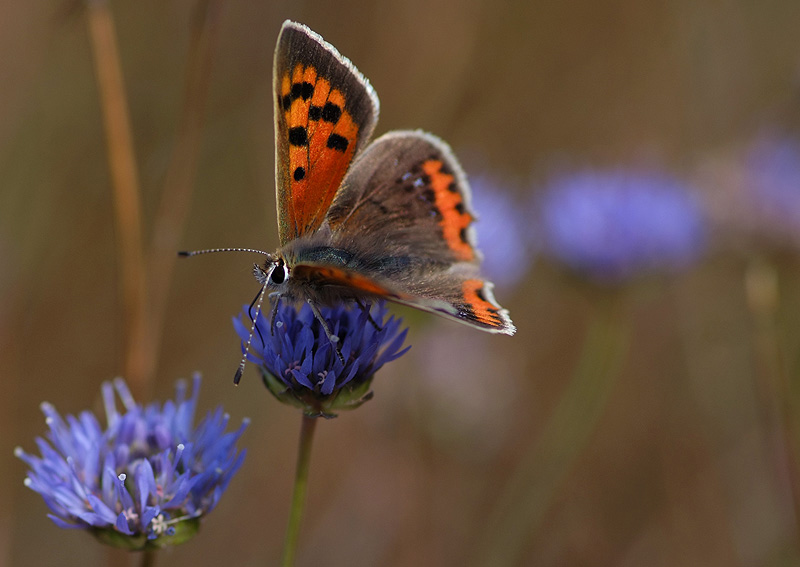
(15, 375, 247, 550)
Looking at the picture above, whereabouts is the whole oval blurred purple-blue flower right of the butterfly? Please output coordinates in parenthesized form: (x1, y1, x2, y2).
(541, 170, 706, 283)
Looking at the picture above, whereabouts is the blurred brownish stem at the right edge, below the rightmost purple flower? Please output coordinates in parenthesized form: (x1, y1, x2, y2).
(745, 259, 800, 541)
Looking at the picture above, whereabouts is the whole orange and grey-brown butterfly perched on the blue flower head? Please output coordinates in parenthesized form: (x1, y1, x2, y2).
(182, 20, 516, 380)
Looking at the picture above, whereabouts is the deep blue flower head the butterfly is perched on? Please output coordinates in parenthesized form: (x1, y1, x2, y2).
(233, 302, 411, 417)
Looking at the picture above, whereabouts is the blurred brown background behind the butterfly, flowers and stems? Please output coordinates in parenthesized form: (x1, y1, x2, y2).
(0, 0, 800, 566)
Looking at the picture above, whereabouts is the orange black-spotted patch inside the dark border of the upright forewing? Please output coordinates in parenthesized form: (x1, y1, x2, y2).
(280, 63, 359, 236)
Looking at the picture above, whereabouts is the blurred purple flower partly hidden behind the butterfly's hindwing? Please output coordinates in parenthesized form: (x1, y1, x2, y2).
(470, 175, 534, 288)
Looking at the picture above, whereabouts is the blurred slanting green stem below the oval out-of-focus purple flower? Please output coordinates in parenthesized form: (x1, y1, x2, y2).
(476, 291, 628, 566)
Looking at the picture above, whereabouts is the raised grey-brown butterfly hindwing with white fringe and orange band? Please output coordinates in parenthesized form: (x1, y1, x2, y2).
(326, 131, 480, 266)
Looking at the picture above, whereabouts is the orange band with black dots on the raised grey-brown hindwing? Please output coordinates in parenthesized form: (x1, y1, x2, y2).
(422, 159, 475, 261)
